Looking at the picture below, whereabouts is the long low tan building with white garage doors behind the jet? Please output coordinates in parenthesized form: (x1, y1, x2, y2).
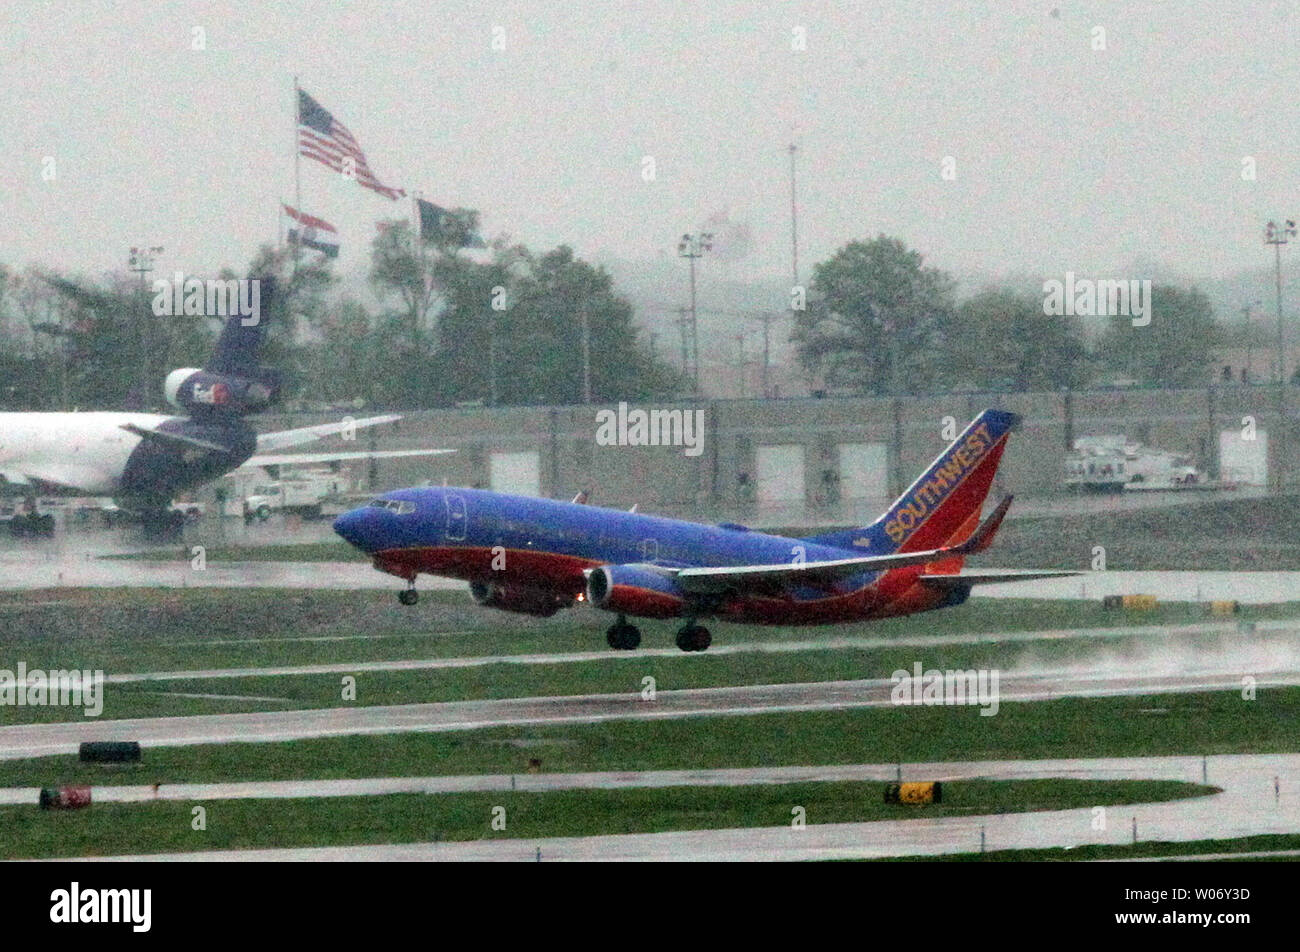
(248, 385, 1300, 527)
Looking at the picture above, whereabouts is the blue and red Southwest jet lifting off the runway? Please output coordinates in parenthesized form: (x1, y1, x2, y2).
(334, 410, 1074, 652)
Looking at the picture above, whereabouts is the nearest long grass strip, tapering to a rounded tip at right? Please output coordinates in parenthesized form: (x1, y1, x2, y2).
(0, 780, 1217, 860)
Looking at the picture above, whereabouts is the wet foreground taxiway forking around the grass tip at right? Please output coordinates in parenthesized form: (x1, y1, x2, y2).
(45, 754, 1300, 862)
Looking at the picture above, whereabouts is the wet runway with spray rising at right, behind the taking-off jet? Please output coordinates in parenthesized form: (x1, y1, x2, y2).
(0, 671, 1300, 760)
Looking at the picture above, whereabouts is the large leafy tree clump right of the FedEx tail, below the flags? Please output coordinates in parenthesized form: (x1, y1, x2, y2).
(371, 226, 680, 407)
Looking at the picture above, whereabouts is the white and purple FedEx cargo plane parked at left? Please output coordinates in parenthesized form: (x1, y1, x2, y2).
(0, 277, 451, 531)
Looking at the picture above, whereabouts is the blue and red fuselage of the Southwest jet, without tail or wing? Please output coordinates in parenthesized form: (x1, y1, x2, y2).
(335, 488, 965, 624)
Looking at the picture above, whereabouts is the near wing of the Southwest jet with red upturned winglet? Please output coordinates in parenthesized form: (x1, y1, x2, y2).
(672, 496, 1011, 594)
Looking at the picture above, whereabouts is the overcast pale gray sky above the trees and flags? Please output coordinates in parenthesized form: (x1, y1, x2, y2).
(0, 0, 1300, 286)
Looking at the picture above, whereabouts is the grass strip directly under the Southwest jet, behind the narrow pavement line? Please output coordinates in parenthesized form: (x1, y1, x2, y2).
(0, 588, 1300, 686)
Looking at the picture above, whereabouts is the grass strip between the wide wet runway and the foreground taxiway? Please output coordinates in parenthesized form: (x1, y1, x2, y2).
(0, 688, 1300, 787)
